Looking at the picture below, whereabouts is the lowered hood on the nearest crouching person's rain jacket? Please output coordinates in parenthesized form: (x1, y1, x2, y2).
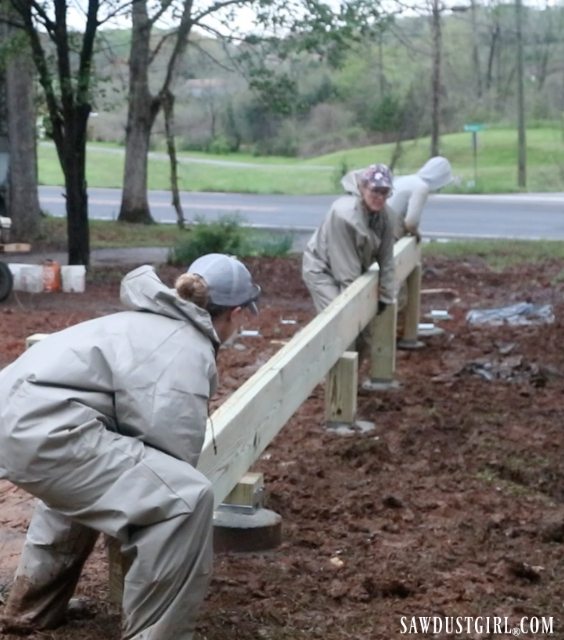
(120, 265, 219, 345)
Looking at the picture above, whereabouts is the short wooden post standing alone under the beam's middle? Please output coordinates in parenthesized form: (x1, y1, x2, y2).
(325, 351, 358, 424)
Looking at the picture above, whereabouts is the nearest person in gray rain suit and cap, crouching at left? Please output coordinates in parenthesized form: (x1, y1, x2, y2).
(0, 254, 260, 640)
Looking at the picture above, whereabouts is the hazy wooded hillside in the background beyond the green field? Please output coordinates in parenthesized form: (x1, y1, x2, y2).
(83, 3, 564, 157)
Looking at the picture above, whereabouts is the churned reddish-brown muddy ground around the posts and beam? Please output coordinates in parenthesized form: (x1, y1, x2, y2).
(0, 252, 564, 640)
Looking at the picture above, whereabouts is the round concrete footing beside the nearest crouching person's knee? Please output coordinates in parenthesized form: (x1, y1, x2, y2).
(213, 508, 282, 553)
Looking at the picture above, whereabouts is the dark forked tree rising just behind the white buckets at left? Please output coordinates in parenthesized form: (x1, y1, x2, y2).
(7, 0, 128, 265)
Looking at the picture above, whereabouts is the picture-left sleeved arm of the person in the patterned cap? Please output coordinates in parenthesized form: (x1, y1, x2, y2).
(326, 210, 362, 291)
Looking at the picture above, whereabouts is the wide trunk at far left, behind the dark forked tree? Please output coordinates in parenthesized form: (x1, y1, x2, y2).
(6, 30, 40, 242)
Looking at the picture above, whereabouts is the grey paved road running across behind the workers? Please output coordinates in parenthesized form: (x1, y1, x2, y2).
(40, 187, 564, 240)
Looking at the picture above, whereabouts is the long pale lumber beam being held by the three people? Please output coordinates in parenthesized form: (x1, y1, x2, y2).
(198, 238, 420, 504)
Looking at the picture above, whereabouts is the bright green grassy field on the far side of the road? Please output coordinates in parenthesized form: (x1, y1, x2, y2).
(38, 126, 564, 195)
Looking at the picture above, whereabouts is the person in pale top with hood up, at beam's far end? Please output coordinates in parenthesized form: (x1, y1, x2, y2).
(388, 156, 453, 240)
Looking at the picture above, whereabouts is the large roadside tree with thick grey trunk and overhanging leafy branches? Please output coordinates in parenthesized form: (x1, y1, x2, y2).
(119, 0, 392, 224)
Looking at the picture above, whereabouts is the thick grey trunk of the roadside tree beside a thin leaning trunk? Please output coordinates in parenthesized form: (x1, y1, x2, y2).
(118, 0, 160, 224)
